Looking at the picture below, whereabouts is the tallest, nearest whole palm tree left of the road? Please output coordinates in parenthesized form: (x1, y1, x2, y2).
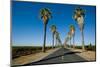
(40, 8, 51, 52)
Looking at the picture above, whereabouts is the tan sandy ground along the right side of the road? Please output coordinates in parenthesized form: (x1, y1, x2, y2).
(70, 49, 96, 61)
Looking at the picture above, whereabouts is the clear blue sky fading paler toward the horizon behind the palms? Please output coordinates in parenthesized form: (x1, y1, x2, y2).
(12, 1, 96, 46)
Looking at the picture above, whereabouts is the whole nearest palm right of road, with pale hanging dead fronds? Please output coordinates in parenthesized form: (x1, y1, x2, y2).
(73, 7, 85, 51)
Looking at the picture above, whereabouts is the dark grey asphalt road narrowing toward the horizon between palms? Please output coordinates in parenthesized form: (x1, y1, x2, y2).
(23, 48, 87, 66)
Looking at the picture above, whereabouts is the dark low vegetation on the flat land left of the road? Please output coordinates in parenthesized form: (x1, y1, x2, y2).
(12, 46, 52, 59)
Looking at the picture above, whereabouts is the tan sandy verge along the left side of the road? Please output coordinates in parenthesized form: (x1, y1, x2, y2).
(12, 48, 60, 66)
